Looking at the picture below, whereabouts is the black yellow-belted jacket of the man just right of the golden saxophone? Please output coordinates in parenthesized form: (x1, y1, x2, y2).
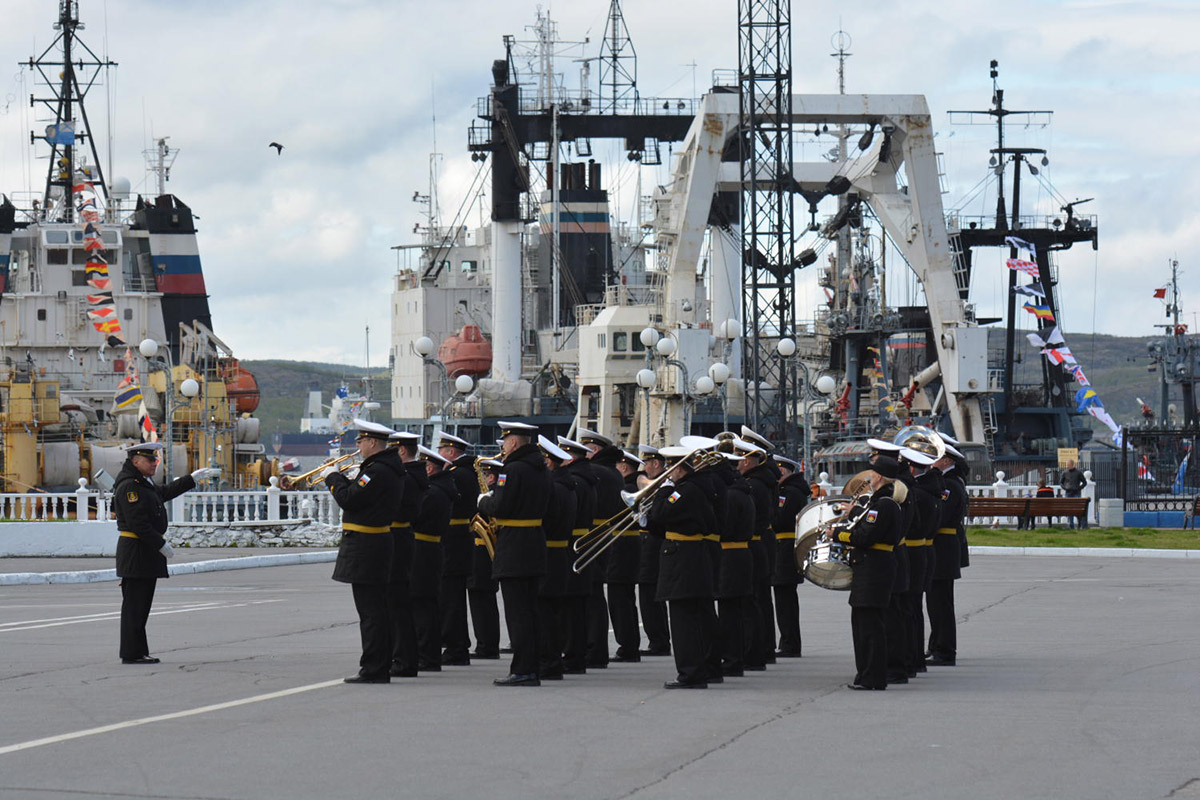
(479, 444, 551, 579)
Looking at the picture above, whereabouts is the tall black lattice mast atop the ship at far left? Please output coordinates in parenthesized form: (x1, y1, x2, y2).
(25, 0, 116, 222)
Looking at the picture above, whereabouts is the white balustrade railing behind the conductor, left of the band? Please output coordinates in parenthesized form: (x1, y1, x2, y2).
(0, 477, 342, 527)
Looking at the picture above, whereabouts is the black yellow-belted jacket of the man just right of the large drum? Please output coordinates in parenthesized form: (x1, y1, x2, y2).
(836, 486, 904, 608)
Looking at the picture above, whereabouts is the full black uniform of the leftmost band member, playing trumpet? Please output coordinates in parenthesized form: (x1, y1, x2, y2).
(325, 450, 404, 682)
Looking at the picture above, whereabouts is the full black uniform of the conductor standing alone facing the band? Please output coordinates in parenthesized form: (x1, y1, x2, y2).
(113, 457, 196, 661)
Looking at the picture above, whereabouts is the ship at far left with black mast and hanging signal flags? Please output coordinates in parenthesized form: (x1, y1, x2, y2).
(0, 0, 265, 492)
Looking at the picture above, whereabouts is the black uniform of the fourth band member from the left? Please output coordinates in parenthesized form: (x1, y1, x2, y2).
(438, 456, 477, 664)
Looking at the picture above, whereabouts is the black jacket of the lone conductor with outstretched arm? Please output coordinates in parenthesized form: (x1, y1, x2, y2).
(113, 458, 196, 578)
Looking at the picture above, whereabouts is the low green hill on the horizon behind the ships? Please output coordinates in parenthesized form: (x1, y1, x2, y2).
(242, 329, 1178, 443)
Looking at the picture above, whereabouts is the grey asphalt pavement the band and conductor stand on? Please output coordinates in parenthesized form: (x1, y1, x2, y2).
(0, 553, 1200, 800)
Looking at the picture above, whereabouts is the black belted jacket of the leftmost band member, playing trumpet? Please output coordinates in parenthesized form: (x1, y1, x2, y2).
(325, 450, 404, 584)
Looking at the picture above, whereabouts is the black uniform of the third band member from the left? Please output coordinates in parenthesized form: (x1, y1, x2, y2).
(408, 461, 458, 672)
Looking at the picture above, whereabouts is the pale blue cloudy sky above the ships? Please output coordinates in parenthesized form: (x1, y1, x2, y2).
(0, 0, 1200, 366)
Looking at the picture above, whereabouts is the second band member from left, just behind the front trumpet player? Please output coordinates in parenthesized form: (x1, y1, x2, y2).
(388, 431, 430, 678)
